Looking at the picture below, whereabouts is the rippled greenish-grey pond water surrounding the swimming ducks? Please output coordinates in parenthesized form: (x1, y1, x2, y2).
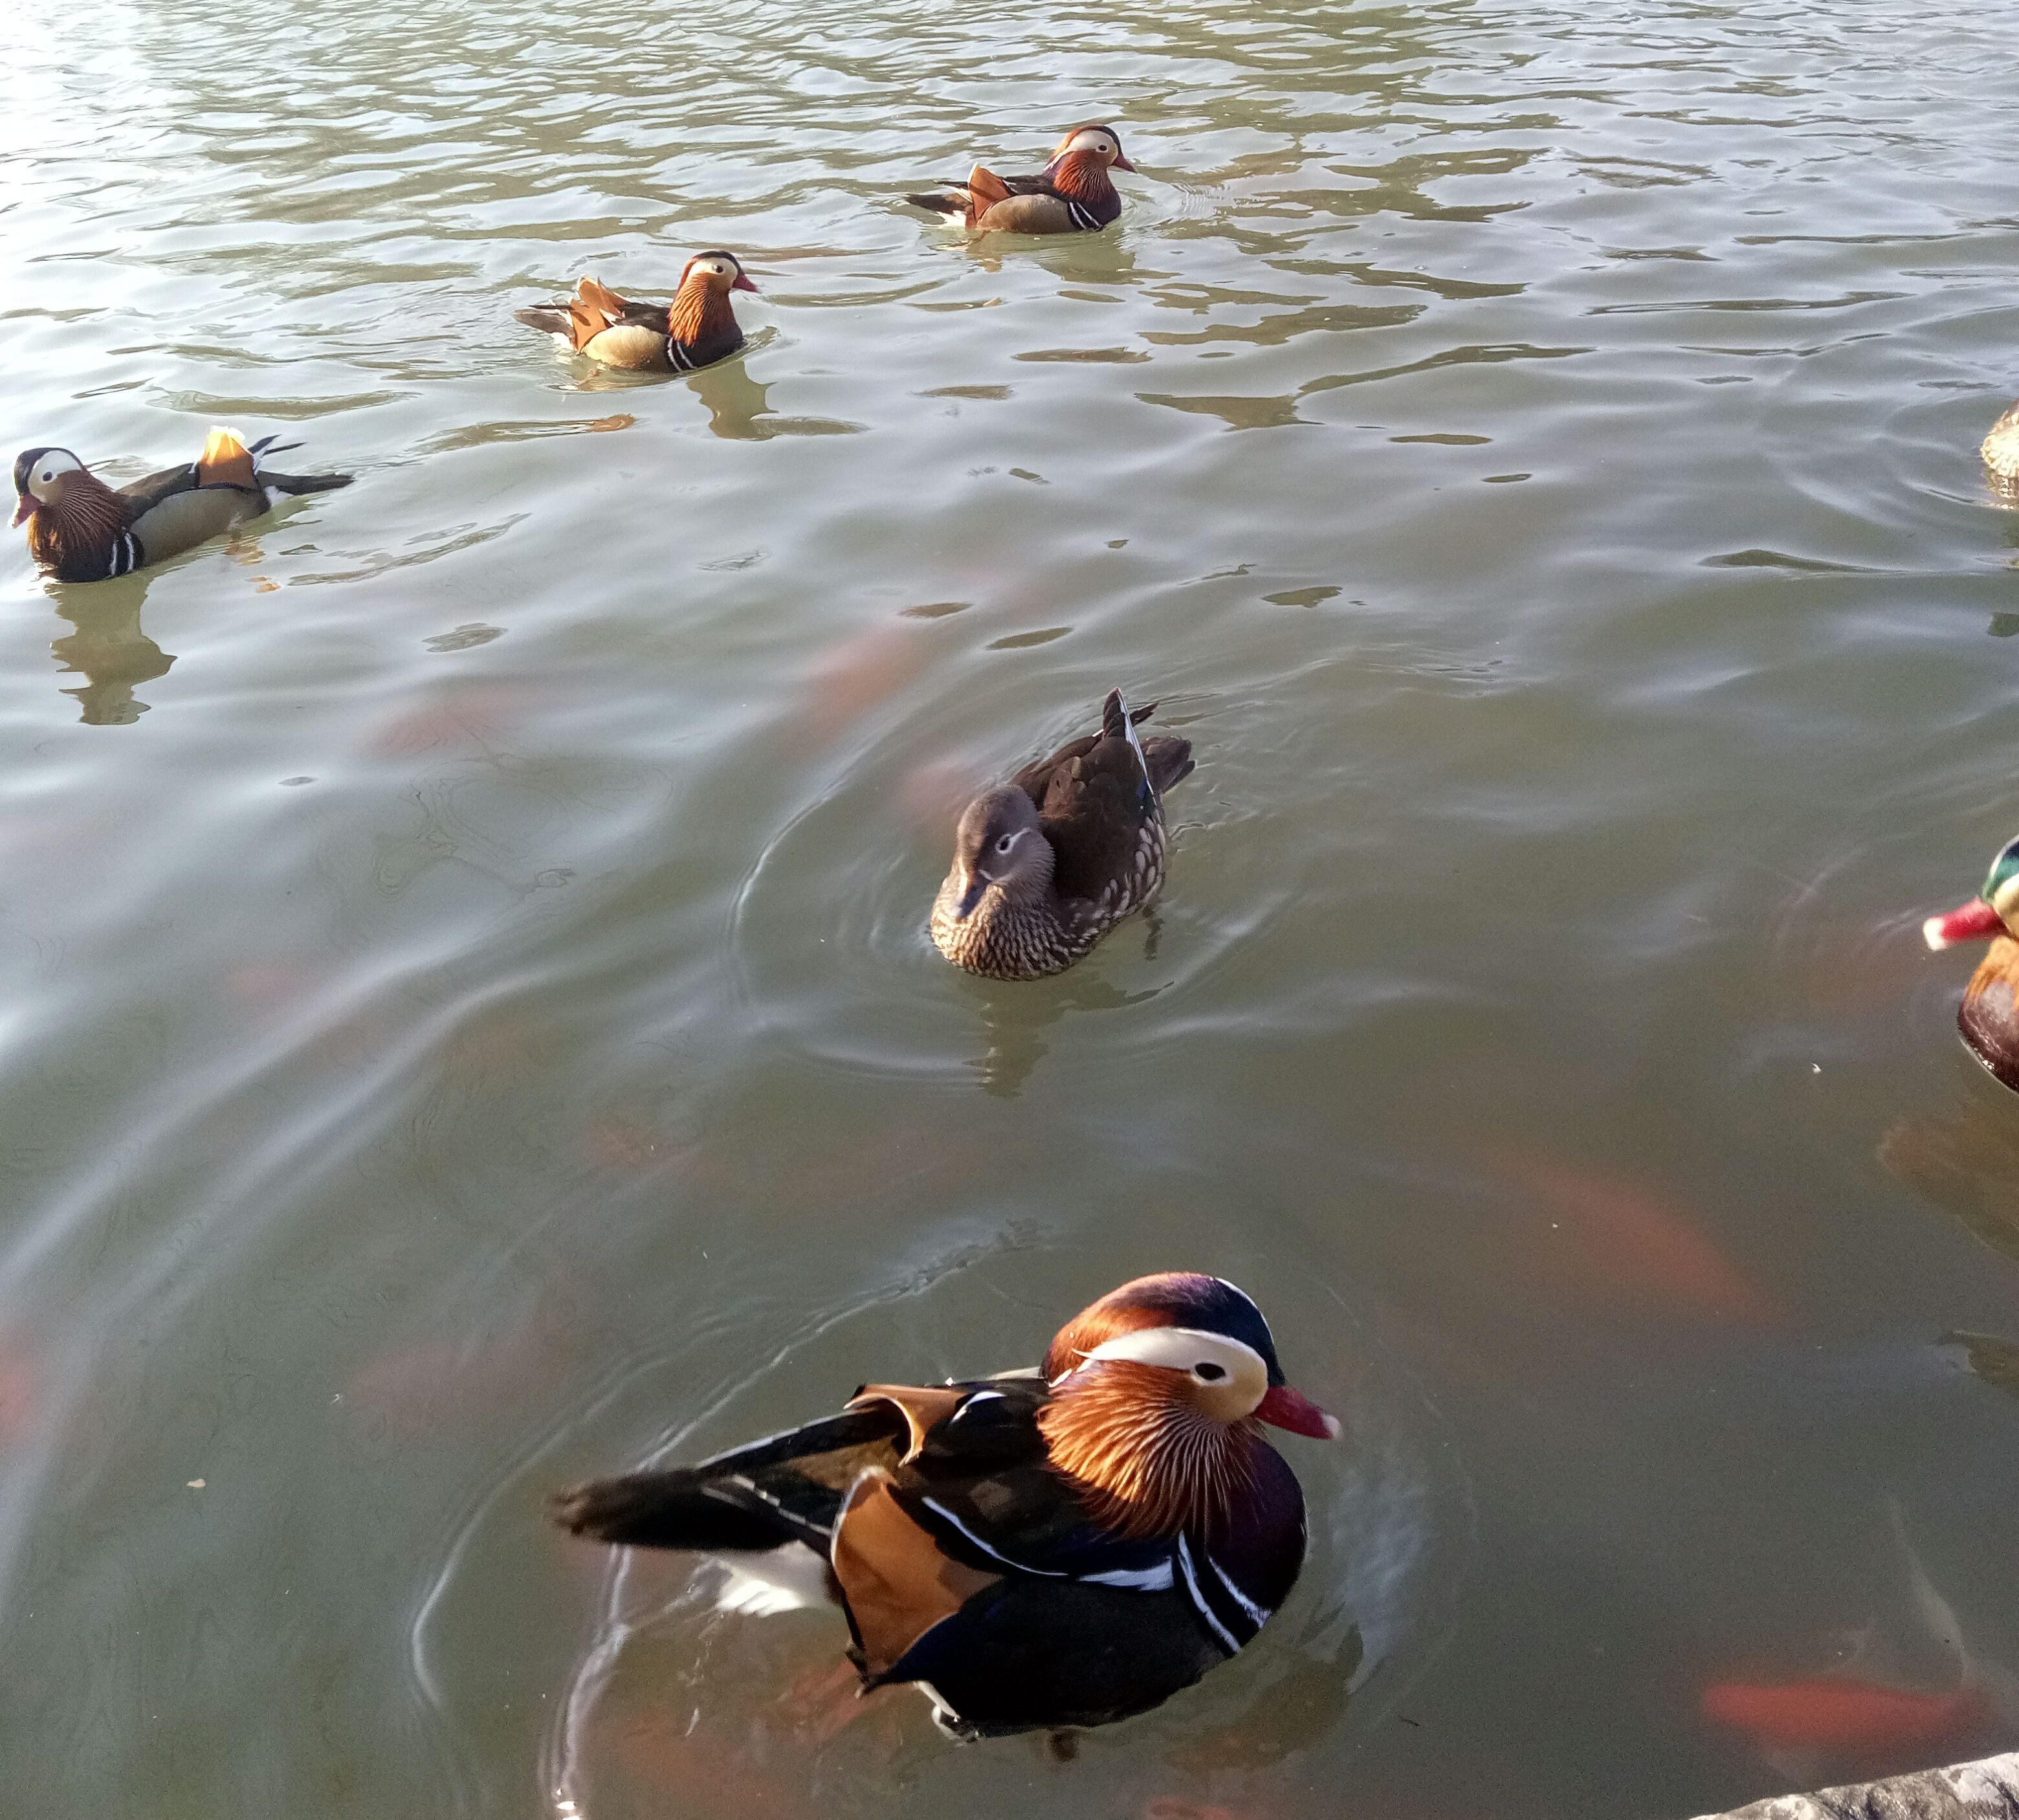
(12, 0, 2019, 1820)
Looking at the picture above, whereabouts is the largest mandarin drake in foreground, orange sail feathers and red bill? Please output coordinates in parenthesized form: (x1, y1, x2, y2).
(555, 1272, 1341, 1737)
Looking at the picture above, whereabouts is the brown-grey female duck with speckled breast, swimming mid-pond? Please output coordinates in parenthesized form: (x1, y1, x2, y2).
(931, 689, 1193, 980)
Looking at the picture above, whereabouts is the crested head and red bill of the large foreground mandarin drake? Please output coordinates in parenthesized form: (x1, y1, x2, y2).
(1044, 1271, 1341, 1440)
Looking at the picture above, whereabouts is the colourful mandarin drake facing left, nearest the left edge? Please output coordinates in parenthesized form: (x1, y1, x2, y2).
(14, 430, 351, 582)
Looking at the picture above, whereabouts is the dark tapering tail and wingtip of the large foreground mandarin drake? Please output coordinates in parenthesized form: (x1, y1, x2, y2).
(553, 1406, 907, 1553)
